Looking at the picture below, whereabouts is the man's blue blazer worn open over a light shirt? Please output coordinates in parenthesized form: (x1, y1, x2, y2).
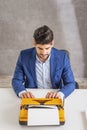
(12, 48, 75, 97)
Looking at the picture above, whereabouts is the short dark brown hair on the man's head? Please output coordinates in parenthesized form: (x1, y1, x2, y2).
(33, 25, 54, 44)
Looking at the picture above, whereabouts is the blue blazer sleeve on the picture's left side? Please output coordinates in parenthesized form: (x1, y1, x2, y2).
(12, 53, 25, 95)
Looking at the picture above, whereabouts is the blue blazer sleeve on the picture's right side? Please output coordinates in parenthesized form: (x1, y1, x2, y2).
(60, 54, 75, 97)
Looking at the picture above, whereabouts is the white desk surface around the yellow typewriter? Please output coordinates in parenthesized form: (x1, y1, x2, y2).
(0, 88, 87, 130)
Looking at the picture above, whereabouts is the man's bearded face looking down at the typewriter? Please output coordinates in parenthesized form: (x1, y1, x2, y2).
(34, 42, 53, 62)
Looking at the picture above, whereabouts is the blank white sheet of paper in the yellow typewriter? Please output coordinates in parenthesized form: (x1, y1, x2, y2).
(27, 105, 60, 126)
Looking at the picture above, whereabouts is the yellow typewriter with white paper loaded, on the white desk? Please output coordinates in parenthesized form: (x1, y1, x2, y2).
(19, 98, 65, 126)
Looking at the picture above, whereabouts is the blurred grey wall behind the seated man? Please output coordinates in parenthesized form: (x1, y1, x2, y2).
(0, 0, 87, 77)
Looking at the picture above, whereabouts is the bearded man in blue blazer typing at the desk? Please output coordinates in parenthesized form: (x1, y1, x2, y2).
(12, 25, 75, 98)
